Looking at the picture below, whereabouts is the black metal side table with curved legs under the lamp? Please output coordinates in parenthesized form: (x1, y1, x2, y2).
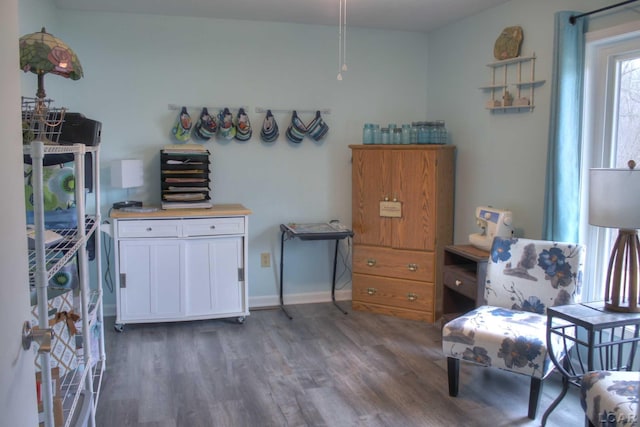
(542, 301, 640, 426)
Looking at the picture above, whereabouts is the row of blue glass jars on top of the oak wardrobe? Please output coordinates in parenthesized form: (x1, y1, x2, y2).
(362, 120, 448, 144)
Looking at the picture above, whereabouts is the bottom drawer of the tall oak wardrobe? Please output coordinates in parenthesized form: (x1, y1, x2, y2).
(352, 274, 434, 312)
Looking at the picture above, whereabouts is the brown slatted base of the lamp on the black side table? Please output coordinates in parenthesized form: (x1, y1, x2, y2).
(604, 229, 640, 313)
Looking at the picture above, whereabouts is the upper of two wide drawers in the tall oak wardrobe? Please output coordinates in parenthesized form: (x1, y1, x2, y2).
(353, 245, 435, 282)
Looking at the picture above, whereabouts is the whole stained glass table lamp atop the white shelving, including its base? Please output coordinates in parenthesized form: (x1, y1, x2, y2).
(19, 27, 83, 143)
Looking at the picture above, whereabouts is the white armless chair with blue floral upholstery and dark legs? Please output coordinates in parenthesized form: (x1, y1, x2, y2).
(442, 237, 585, 419)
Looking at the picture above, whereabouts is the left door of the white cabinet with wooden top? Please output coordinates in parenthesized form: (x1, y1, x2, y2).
(118, 239, 184, 321)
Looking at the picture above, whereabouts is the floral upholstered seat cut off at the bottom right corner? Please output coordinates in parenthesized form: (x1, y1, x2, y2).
(580, 371, 640, 427)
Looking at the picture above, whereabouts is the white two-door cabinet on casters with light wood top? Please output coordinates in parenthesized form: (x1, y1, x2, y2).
(111, 205, 251, 330)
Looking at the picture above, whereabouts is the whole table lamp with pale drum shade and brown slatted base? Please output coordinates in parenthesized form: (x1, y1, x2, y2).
(589, 160, 640, 313)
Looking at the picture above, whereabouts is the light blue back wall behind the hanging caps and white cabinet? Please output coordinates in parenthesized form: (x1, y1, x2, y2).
(18, 0, 427, 312)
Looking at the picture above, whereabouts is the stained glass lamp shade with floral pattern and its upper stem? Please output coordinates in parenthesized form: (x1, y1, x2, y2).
(20, 27, 83, 99)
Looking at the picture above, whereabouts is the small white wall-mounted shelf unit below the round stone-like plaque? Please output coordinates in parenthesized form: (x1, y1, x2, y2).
(480, 54, 544, 111)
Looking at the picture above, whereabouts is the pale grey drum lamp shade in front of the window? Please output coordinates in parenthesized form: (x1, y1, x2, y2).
(589, 169, 640, 230)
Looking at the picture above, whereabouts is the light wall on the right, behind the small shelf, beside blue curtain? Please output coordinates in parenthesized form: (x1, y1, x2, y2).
(427, 0, 639, 243)
